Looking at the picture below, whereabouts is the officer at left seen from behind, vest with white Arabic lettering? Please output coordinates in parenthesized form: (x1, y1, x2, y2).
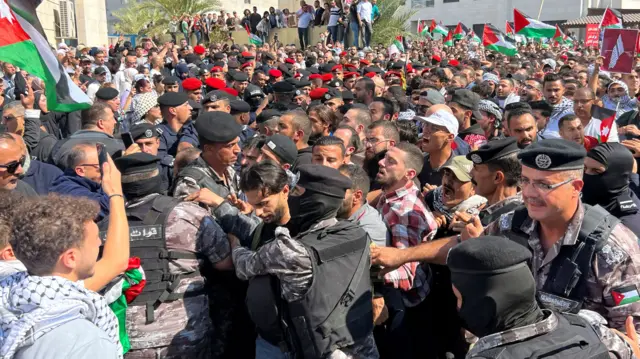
(114, 153, 232, 359)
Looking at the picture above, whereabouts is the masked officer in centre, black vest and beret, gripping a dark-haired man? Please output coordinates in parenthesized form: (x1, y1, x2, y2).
(229, 165, 378, 358)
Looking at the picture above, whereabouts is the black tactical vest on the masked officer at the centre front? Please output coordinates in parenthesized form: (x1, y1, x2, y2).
(247, 221, 373, 359)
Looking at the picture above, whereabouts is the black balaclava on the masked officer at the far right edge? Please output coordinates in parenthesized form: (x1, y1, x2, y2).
(582, 142, 634, 212)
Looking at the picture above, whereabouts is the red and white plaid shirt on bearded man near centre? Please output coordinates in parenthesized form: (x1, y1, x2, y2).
(378, 181, 438, 307)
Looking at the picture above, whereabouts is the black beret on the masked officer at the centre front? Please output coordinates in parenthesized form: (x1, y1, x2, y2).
(297, 165, 351, 198)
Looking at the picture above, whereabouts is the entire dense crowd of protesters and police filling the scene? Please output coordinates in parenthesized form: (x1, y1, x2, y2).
(5, 22, 640, 359)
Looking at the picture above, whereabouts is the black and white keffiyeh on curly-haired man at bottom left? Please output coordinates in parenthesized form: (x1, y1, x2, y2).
(0, 272, 122, 358)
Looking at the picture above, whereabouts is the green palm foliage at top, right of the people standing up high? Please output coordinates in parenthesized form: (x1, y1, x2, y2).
(371, 0, 416, 46)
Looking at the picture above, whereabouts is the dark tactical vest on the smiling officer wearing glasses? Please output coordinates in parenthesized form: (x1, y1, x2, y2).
(509, 204, 620, 313)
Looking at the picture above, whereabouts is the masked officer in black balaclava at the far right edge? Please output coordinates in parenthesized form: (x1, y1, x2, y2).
(582, 142, 640, 236)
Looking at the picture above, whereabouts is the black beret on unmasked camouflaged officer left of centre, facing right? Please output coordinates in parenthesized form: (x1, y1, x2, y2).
(195, 111, 242, 143)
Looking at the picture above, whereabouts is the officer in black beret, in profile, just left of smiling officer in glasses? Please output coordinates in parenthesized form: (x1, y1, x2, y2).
(467, 137, 522, 226)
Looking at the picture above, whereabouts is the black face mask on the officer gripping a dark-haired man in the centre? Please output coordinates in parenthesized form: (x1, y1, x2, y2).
(287, 191, 343, 237)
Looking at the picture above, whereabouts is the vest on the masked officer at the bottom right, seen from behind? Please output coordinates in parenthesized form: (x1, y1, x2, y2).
(472, 313, 609, 359)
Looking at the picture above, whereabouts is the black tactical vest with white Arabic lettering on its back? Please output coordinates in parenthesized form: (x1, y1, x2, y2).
(100, 195, 204, 324)
